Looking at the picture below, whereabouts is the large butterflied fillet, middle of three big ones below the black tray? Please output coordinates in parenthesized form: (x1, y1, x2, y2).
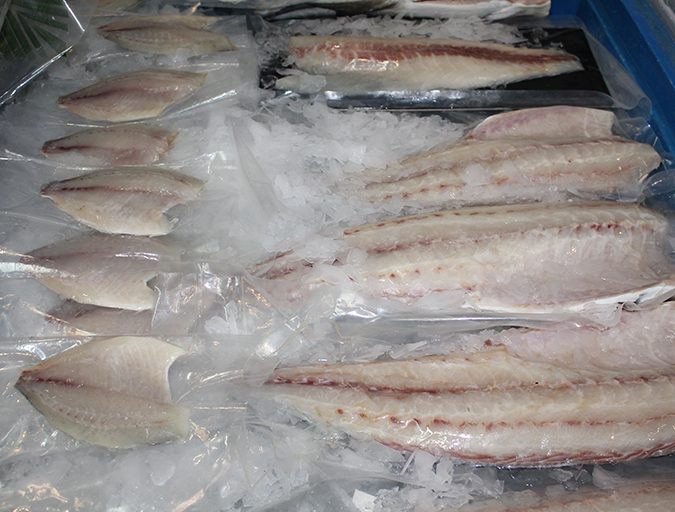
(251, 201, 675, 314)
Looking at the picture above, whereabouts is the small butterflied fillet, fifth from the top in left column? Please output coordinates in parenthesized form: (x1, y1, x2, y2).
(20, 233, 180, 311)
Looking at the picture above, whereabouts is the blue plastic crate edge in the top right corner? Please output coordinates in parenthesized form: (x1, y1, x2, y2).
(551, 0, 675, 153)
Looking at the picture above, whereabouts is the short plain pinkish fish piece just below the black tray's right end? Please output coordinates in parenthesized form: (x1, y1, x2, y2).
(467, 105, 616, 141)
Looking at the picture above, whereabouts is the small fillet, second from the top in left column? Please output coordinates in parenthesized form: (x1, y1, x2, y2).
(58, 69, 207, 122)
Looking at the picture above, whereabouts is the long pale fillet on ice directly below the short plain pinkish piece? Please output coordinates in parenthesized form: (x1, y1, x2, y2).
(363, 137, 661, 208)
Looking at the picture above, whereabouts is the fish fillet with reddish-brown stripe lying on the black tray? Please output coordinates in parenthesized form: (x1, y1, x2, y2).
(289, 36, 582, 89)
